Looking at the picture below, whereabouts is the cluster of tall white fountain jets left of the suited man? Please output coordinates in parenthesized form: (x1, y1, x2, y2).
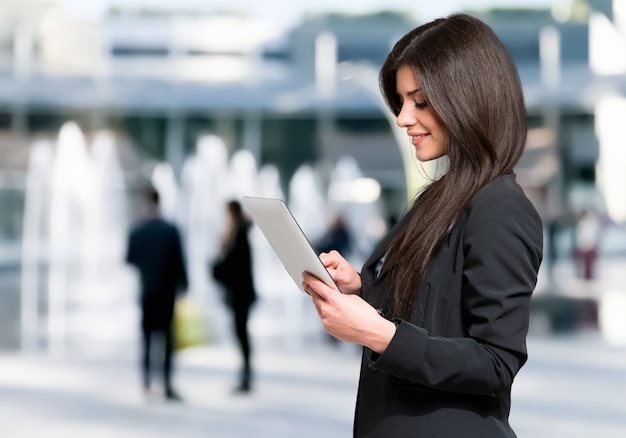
(21, 122, 136, 354)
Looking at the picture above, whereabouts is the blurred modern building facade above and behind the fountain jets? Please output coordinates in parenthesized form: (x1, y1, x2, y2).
(0, 0, 626, 233)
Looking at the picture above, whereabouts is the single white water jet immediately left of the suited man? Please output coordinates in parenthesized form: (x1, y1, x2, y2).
(66, 131, 133, 349)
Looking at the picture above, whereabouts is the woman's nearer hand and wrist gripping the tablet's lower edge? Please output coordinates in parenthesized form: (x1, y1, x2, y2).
(302, 272, 396, 353)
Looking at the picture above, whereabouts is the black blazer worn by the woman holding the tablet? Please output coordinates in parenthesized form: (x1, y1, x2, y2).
(354, 174, 543, 438)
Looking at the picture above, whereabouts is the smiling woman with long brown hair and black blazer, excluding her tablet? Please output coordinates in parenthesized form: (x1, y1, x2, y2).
(303, 14, 543, 438)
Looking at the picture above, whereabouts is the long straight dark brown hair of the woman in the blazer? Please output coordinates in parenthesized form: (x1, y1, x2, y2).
(379, 14, 527, 317)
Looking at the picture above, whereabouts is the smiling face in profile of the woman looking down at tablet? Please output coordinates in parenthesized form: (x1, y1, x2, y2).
(396, 66, 446, 161)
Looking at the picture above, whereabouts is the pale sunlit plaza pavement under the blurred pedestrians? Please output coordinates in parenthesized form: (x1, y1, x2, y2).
(0, 332, 626, 438)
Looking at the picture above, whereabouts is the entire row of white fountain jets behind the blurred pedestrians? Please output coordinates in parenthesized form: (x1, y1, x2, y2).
(22, 122, 382, 354)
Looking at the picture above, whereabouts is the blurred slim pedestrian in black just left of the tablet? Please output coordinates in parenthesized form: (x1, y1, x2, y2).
(212, 200, 256, 393)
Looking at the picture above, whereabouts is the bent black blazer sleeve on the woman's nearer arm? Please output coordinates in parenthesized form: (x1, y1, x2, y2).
(369, 185, 543, 396)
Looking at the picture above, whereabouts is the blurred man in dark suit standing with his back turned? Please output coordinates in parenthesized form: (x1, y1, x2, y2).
(126, 187, 187, 401)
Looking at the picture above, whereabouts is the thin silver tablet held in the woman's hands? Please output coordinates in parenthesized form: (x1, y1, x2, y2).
(242, 196, 339, 290)
